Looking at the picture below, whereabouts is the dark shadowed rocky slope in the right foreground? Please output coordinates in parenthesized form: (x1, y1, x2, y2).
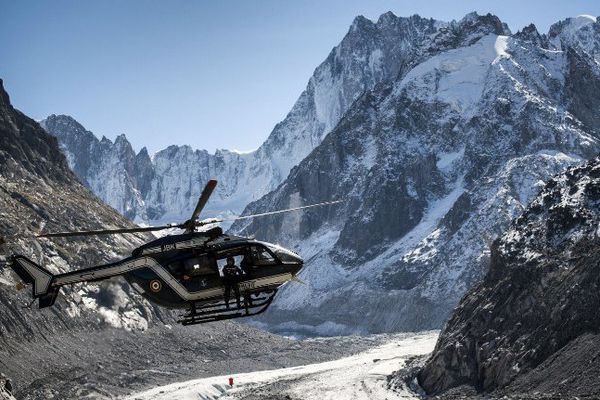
(419, 158, 600, 395)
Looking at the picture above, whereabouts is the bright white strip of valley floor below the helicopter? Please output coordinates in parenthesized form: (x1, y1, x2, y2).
(126, 332, 438, 400)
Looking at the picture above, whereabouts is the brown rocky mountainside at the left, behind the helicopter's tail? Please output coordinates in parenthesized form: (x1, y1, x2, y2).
(0, 81, 172, 396)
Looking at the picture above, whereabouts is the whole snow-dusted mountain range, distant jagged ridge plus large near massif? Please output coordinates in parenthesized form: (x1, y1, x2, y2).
(43, 13, 600, 333)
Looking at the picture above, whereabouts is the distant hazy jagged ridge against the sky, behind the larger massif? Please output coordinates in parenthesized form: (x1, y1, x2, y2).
(42, 13, 440, 222)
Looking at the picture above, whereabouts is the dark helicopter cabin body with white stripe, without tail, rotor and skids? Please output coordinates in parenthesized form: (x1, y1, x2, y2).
(121, 233, 303, 308)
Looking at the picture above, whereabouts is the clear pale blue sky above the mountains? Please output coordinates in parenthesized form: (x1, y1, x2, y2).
(0, 0, 600, 152)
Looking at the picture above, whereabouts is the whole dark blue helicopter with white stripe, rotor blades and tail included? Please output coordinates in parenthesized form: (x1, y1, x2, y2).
(8, 180, 341, 325)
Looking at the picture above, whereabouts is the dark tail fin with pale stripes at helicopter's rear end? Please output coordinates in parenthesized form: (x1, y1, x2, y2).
(10, 255, 59, 308)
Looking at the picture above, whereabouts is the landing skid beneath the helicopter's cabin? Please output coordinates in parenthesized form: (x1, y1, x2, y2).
(177, 289, 277, 325)
